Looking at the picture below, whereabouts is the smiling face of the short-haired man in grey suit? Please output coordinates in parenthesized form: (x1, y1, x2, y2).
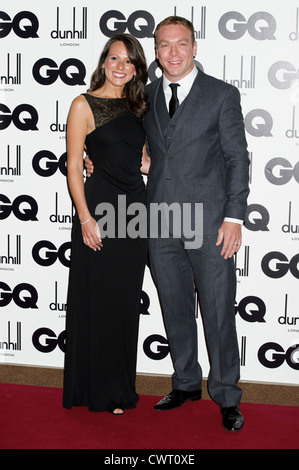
(156, 24, 197, 82)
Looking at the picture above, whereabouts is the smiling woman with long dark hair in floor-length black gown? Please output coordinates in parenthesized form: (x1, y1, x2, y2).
(63, 34, 149, 415)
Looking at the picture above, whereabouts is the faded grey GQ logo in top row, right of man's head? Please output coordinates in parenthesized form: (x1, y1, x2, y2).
(218, 11, 276, 41)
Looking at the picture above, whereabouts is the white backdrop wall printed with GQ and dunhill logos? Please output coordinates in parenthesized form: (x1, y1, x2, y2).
(0, 0, 299, 384)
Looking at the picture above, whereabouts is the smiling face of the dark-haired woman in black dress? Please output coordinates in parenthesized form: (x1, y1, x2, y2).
(103, 41, 136, 87)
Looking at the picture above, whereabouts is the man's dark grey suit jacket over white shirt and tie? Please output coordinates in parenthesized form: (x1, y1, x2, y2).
(145, 70, 249, 234)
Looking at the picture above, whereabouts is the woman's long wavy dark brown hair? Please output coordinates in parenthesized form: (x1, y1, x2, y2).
(88, 34, 148, 120)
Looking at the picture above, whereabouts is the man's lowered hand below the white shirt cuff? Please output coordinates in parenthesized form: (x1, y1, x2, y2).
(216, 222, 242, 259)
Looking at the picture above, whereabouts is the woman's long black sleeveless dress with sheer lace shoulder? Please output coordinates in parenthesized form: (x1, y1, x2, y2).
(63, 94, 147, 411)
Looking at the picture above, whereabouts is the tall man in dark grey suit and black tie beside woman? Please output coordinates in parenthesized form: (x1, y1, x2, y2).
(145, 17, 249, 431)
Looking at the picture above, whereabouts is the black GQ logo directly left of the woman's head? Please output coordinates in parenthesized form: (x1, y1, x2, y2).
(32, 58, 86, 86)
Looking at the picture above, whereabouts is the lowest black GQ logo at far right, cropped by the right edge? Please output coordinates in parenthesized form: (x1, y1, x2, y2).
(258, 342, 299, 370)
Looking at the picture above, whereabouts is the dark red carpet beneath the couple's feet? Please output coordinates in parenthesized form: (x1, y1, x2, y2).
(0, 384, 299, 455)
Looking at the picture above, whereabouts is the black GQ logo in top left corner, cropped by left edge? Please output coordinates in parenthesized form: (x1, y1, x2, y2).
(0, 11, 39, 39)
